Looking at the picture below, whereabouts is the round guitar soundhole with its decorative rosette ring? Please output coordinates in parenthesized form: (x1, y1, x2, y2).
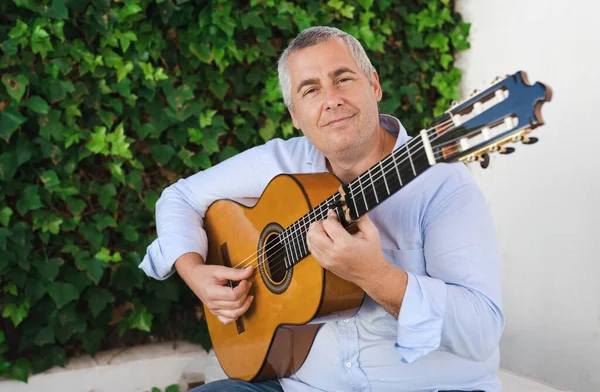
(258, 223, 293, 294)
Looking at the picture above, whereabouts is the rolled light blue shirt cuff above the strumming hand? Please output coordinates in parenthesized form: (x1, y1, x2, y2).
(138, 228, 208, 280)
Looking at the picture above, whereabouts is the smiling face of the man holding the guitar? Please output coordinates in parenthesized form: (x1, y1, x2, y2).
(288, 37, 381, 159)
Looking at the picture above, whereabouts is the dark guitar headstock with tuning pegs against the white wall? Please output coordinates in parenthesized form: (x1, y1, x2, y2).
(430, 71, 552, 168)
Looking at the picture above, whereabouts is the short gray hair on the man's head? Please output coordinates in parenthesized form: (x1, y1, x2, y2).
(277, 26, 375, 112)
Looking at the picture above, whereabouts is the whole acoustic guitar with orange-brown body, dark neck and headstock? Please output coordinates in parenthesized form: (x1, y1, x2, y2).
(204, 72, 552, 381)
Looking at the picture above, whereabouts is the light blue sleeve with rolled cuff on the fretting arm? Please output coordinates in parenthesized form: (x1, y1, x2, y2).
(396, 164, 504, 363)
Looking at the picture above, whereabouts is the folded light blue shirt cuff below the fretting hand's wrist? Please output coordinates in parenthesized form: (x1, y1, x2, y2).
(396, 272, 447, 363)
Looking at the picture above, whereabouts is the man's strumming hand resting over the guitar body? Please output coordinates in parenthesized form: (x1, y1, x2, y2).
(175, 253, 254, 324)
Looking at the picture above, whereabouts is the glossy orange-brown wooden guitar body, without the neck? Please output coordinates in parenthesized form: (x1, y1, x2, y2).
(204, 173, 364, 381)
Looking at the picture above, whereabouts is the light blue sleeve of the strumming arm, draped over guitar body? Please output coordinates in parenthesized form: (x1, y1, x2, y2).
(139, 143, 281, 280)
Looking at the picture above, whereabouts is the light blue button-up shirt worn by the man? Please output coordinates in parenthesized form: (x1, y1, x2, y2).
(140, 115, 504, 392)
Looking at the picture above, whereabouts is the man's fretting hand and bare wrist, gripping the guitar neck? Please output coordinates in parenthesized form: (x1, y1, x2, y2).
(306, 211, 408, 318)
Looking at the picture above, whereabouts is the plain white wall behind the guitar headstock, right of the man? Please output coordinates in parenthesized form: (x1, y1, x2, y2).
(456, 0, 600, 392)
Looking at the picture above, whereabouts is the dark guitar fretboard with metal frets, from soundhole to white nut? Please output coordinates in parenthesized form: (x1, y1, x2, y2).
(279, 137, 430, 268)
